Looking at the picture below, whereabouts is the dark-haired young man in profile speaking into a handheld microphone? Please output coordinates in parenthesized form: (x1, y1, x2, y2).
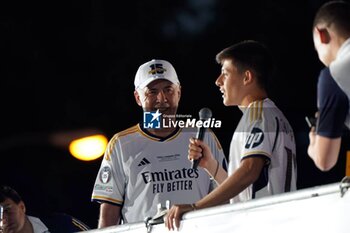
(165, 41, 296, 230)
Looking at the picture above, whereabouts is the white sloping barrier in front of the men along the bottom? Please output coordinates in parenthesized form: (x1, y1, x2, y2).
(82, 177, 350, 233)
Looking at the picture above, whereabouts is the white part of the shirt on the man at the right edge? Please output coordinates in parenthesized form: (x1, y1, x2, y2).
(329, 38, 350, 129)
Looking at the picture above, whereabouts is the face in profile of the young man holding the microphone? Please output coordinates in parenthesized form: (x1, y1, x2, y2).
(215, 60, 245, 106)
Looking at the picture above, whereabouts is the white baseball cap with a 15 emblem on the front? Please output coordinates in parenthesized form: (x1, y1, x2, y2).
(134, 59, 180, 89)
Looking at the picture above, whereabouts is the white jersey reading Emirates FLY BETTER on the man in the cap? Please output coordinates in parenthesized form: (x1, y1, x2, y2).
(92, 125, 226, 223)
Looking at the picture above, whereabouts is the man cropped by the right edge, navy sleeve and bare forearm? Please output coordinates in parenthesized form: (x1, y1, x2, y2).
(308, 1, 350, 171)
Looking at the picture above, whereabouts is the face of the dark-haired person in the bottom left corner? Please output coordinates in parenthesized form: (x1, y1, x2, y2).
(0, 198, 26, 233)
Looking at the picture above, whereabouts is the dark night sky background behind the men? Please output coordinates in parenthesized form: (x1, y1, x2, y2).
(0, 0, 347, 228)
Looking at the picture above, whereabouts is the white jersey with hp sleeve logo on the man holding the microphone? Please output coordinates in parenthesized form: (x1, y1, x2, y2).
(228, 99, 296, 203)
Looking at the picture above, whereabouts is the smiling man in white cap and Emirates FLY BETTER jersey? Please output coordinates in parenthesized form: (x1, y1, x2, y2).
(92, 60, 226, 228)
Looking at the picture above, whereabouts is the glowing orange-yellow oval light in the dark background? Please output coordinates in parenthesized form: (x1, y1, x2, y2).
(69, 134, 108, 161)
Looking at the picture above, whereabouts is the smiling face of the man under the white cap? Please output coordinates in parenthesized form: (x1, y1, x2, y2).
(135, 79, 181, 115)
